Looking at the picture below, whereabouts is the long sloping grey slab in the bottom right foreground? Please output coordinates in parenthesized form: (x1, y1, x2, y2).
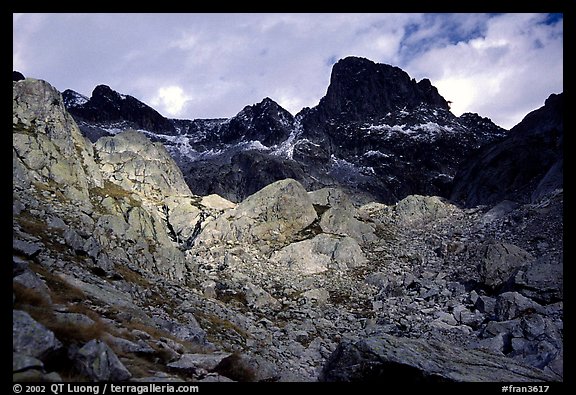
(320, 334, 555, 382)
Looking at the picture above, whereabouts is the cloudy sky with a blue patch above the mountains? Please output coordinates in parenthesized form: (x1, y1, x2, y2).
(12, 13, 563, 128)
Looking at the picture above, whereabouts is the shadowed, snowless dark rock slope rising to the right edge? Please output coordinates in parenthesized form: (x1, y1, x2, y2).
(451, 94, 564, 206)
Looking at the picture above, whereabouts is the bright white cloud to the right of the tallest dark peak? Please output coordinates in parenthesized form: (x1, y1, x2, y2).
(407, 14, 563, 128)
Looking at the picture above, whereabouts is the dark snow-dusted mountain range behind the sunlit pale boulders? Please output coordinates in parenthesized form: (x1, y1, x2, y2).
(63, 57, 506, 203)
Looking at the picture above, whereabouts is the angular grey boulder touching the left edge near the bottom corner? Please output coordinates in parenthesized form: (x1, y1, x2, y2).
(12, 310, 62, 359)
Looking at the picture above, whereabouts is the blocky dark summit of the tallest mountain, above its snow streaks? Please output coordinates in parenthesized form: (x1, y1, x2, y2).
(317, 56, 449, 121)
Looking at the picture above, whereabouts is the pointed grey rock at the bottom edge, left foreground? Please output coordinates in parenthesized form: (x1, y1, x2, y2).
(74, 340, 132, 381)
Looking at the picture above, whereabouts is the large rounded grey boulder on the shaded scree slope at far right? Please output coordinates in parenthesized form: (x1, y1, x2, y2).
(478, 243, 533, 289)
